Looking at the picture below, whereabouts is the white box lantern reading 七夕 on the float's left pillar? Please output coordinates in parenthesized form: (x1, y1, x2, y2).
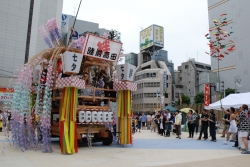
(62, 51, 83, 74)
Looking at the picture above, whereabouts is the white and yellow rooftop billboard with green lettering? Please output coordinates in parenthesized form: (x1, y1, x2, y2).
(140, 24, 164, 50)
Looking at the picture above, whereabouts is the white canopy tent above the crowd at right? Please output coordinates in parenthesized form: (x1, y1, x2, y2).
(205, 92, 250, 110)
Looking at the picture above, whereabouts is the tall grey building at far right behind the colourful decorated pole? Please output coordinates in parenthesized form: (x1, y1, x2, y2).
(208, 0, 250, 93)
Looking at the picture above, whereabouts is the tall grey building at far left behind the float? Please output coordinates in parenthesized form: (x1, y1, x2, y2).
(0, 0, 63, 87)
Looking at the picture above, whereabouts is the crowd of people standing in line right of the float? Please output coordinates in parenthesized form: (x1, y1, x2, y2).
(132, 104, 250, 154)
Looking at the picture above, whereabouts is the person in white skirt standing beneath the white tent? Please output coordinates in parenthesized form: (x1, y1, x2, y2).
(222, 107, 237, 144)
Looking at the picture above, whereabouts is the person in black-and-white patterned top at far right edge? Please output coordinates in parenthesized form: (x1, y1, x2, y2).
(237, 104, 250, 154)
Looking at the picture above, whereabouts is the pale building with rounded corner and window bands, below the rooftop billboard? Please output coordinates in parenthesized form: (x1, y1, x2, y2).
(132, 53, 172, 113)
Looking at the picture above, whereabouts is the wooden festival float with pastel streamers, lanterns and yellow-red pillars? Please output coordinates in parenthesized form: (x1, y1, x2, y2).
(2, 19, 137, 154)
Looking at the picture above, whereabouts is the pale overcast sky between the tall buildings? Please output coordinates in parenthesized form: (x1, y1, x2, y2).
(63, 0, 211, 69)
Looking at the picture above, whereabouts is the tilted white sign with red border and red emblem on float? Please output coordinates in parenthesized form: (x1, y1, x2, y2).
(83, 34, 122, 62)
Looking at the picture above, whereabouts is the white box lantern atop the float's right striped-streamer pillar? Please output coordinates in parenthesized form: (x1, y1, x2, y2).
(116, 63, 136, 81)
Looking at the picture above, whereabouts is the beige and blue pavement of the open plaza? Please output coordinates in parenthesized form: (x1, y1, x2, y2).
(0, 130, 250, 167)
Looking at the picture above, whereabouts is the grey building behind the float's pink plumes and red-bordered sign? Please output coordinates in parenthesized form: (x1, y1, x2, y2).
(62, 14, 109, 44)
